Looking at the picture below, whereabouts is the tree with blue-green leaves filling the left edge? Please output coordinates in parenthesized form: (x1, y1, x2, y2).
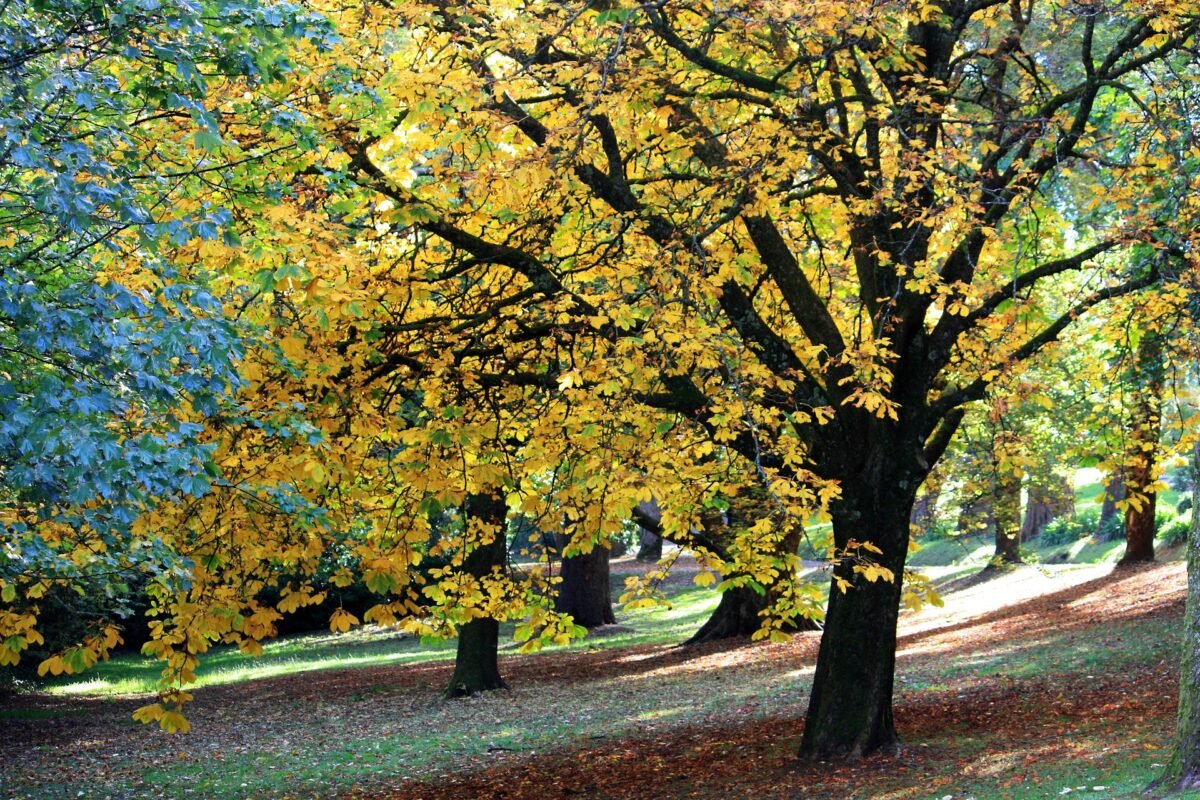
(0, 0, 320, 673)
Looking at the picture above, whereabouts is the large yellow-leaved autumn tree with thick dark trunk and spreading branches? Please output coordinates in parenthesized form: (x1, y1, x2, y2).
(0, 0, 1200, 757)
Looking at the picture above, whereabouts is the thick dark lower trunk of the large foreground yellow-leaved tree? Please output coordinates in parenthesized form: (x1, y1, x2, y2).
(800, 479, 922, 759)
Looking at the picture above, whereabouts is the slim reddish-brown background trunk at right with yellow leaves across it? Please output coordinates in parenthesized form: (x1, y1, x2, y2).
(1117, 331, 1163, 566)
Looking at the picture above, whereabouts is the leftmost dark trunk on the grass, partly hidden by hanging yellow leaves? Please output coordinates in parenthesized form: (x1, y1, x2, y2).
(445, 494, 508, 697)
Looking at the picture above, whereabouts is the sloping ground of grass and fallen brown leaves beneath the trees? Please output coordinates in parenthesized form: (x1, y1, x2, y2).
(0, 563, 1186, 800)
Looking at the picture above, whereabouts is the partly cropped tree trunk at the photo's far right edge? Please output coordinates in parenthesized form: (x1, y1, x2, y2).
(1151, 447, 1200, 793)
